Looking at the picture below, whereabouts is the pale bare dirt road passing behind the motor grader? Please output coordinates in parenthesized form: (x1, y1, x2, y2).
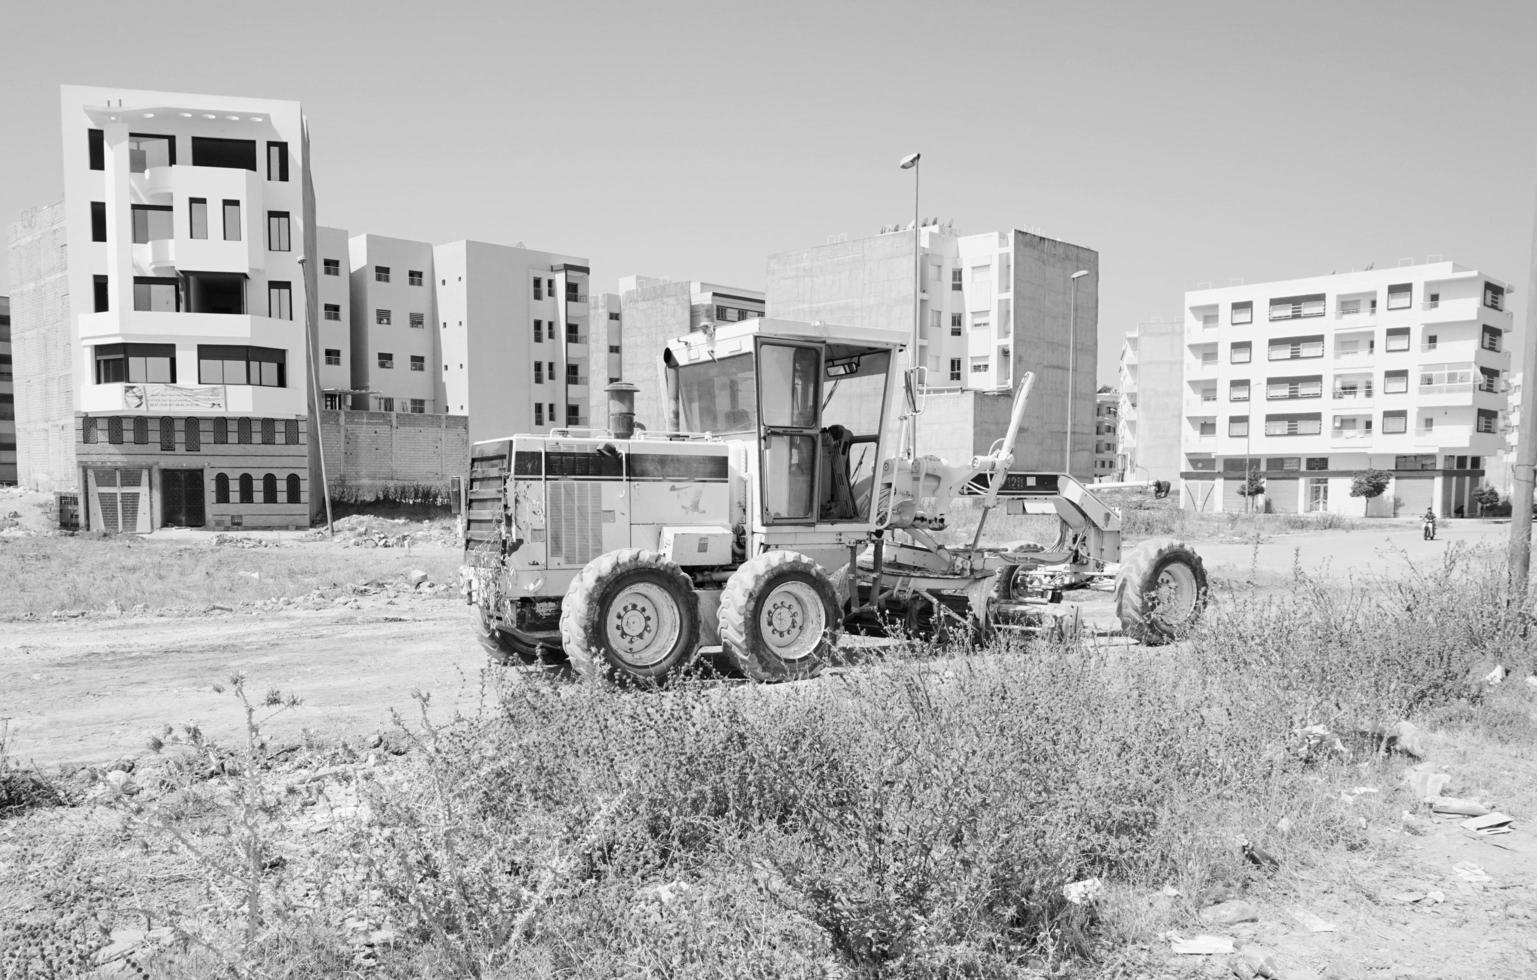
(0, 522, 1509, 765)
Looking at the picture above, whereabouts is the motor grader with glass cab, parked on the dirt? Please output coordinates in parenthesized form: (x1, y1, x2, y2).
(461, 318, 1207, 684)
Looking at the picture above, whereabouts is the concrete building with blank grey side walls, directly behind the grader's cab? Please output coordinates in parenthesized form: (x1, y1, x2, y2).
(767, 224, 1099, 479)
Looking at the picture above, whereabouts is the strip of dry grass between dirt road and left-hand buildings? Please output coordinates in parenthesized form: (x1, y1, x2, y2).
(0, 536, 460, 621)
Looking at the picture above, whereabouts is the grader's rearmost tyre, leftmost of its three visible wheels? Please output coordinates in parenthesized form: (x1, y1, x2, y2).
(561, 548, 699, 685)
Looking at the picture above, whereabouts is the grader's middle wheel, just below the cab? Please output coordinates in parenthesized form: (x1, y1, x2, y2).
(721, 551, 842, 680)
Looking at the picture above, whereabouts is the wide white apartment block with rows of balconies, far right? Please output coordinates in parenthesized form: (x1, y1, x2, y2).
(1180, 261, 1512, 515)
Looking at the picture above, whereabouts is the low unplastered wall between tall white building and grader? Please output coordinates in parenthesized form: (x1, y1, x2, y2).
(320, 412, 470, 499)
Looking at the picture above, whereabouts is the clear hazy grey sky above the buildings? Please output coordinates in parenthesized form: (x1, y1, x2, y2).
(0, 0, 1537, 381)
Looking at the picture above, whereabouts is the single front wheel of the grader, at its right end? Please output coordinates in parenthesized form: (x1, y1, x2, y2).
(1116, 538, 1207, 647)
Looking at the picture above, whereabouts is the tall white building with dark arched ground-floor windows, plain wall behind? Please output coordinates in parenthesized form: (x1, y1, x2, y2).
(11, 86, 318, 531)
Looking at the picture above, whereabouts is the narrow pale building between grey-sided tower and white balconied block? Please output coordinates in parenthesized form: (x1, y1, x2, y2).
(1116, 319, 1185, 487)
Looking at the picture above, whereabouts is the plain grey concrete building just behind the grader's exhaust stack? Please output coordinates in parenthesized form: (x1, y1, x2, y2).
(614, 276, 765, 430)
